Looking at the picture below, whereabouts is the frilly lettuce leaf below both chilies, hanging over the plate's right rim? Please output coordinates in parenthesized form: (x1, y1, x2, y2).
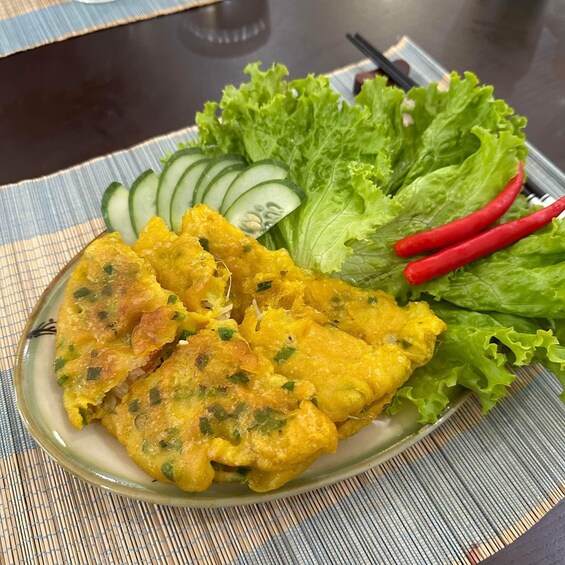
(389, 304, 565, 423)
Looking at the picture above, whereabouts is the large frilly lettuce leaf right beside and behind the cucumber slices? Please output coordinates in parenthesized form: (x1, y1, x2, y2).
(196, 64, 395, 273)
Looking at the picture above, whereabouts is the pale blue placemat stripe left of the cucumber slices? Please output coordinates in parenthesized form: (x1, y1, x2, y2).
(0, 129, 195, 245)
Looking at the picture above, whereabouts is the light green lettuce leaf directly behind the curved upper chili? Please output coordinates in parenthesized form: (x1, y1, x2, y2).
(339, 126, 523, 300)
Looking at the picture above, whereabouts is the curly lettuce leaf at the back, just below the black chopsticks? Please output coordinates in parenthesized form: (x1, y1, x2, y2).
(356, 72, 526, 194)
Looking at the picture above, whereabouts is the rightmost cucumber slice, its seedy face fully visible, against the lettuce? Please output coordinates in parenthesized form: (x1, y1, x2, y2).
(224, 179, 304, 238)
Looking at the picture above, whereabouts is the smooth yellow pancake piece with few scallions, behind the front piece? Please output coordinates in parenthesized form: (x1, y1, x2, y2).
(240, 308, 412, 430)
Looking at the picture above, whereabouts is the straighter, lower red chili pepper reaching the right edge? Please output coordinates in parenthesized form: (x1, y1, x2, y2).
(404, 196, 565, 285)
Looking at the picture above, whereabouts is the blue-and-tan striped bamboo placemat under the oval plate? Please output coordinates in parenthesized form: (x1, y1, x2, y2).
(0, 39, 565, 564)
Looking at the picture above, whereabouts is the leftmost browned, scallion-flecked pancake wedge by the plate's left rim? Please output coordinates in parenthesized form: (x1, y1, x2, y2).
(55, 233, 195, 428)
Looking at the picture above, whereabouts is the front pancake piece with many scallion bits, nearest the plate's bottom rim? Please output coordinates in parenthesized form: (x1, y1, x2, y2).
(99, 321, 337, 491)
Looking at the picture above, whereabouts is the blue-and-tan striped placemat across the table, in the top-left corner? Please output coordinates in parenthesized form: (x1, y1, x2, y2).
(0, 0, 221, 57)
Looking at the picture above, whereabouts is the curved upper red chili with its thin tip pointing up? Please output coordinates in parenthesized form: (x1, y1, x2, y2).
(394, 161, 524, 257)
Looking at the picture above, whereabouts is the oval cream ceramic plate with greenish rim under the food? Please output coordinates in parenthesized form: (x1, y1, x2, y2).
(15, 249, 467, 507)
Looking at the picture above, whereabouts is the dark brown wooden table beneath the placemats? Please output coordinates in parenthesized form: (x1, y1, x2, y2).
(0, 0, 565, 563)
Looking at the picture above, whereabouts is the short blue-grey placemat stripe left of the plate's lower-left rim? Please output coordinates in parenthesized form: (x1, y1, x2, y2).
(0, 371, 37, 457)
